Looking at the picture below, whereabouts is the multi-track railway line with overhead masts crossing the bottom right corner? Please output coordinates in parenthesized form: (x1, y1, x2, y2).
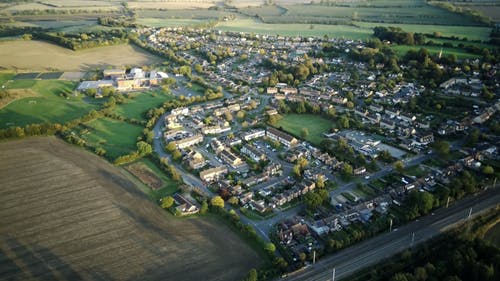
(286, 187, 500, 281)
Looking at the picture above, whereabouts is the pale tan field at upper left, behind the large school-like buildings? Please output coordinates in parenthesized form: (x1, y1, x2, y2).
(0, 40, 161, 71)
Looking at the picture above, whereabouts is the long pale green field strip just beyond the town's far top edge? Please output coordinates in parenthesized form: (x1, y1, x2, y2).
(214, 18, 373, 40)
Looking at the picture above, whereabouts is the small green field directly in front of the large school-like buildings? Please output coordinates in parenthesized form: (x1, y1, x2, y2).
(115, 90, 173, 120)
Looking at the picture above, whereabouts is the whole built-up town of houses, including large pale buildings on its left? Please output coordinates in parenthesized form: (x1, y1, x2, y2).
(71, 28, 500, 272)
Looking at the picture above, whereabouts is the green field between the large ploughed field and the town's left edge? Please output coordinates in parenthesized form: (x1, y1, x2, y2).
(79, 118, 142, 159)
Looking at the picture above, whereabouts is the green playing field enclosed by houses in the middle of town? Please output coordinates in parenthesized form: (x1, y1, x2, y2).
(276, 114, 333, 145)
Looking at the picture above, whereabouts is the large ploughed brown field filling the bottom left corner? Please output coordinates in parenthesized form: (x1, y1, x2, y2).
(0, 137, 259, 281)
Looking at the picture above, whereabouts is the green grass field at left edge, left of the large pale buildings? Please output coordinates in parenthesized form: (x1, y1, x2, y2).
(0, 78, 97, 128)
